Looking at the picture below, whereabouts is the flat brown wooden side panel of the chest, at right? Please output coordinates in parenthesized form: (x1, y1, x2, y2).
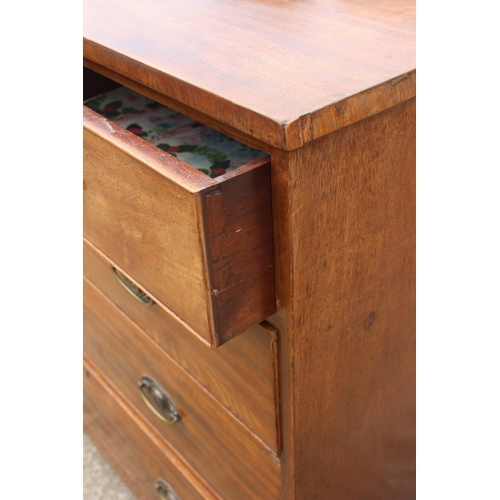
(269, 99, 415, 500)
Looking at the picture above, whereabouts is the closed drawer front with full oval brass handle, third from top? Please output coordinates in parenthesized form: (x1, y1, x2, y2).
(84, 282, 281, 499)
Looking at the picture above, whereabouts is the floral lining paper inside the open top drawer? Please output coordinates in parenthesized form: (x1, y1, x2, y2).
(85, 87, 266, 177)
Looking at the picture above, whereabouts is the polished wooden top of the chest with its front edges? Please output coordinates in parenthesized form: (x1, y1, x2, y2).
(84, 0, 415, 150)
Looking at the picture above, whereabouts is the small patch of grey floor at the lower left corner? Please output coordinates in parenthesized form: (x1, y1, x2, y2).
(83, 434, 136, 500)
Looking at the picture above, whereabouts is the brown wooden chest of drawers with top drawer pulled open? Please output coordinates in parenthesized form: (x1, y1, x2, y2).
(84, 0, 415, 500)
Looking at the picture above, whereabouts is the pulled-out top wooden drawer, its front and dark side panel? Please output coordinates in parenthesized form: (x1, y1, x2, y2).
(84, 107, 276, 347)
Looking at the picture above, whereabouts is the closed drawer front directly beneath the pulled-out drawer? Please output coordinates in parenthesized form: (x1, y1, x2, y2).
(83, 241, 279, 453)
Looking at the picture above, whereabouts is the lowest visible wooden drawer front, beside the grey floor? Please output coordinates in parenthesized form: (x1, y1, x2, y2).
(83, 360, 215, 500)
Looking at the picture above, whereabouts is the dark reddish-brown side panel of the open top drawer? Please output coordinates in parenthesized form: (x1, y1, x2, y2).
(202, 163, 276, 344)
